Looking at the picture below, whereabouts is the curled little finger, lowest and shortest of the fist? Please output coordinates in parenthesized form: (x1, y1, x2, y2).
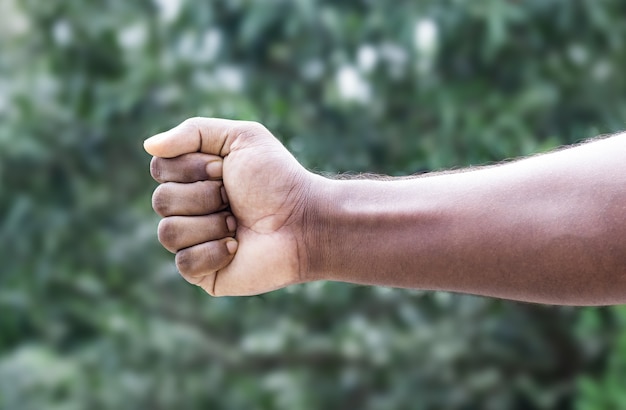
(176, 238, 237, 284)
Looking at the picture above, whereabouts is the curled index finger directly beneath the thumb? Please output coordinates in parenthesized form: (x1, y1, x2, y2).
(150, 152, 223, 183)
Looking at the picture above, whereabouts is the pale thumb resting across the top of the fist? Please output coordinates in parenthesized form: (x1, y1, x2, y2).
(143, 117, 247, 158)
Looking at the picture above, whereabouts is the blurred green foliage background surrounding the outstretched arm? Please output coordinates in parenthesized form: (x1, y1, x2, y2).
(0, 0, 626, 410)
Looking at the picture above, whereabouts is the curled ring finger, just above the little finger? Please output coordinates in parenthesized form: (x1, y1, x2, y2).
(158, 212, 237, 253)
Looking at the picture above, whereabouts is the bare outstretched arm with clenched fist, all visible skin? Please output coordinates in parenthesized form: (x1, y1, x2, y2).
(144, 118, 626, 305)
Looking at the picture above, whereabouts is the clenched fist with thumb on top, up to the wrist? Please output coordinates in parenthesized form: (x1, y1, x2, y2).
(144, 118, 315, 296)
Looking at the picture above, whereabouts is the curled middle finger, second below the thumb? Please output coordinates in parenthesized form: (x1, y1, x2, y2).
(152, 181, 228, 217)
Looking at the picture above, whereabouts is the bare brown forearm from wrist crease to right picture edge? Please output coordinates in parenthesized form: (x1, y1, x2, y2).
(309, 135, 626, 304)
